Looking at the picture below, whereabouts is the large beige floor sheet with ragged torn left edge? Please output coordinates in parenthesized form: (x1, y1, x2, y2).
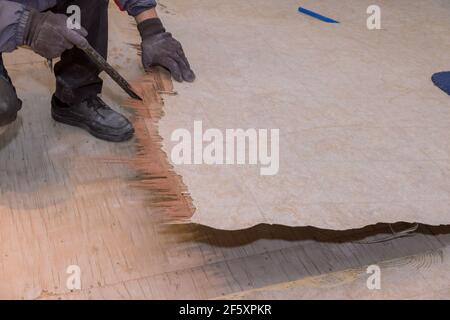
(156, 0, 450, 229)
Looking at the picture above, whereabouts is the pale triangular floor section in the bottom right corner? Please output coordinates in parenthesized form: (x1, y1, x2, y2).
(225, 247, 450, 300)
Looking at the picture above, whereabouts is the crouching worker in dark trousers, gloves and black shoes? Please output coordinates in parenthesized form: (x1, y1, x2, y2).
(0, 0, 195, 142)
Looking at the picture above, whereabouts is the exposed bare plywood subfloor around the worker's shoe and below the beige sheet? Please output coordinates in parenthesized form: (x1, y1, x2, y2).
(0, 3, 450, 299)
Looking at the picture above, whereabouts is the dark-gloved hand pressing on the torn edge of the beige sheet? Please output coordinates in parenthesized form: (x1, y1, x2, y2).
(138, 18, 195, 82)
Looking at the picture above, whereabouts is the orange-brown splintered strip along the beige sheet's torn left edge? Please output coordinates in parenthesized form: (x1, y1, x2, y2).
(124, 70, 195, 222)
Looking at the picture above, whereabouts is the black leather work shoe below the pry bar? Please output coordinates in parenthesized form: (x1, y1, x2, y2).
(52, 95, 134, 142)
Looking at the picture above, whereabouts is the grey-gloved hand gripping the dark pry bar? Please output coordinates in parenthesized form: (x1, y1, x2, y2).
(22, 10, 88, 59)
